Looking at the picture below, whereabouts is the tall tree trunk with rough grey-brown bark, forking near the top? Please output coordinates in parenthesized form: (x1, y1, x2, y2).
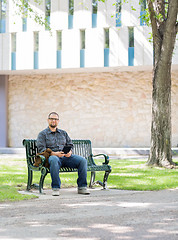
(147, 0, 178, 168)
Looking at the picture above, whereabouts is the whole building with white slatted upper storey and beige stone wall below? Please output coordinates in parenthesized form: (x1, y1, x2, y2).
(0, 0, 178, 147)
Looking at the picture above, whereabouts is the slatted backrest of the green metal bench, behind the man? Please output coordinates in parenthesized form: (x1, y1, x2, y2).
(23, 139, 95, 166)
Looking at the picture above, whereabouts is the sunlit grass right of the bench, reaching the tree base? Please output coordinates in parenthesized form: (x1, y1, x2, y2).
(108, 159, 178, 191)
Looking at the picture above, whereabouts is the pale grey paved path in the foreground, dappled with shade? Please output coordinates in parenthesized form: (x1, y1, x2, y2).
(0, 188, 178, 240)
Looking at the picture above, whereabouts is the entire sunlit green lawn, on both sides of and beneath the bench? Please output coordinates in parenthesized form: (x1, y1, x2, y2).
(0, 159, 178, 202)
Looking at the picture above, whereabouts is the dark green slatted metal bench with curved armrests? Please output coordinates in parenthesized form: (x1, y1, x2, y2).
(23, 139, 111, 193)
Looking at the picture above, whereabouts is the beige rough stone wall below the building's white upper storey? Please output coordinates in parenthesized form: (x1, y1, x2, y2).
(8, 67, 178, 147)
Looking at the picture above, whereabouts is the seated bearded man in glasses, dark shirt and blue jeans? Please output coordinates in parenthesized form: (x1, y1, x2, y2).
(37, 112, 90, 196)
